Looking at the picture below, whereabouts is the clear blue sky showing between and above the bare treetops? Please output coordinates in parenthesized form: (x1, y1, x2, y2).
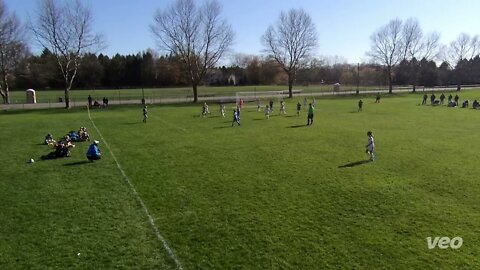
(4, 0, 480, 63)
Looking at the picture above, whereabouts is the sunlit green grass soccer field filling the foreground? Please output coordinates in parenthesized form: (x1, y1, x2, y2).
(0, 91, 480, 269)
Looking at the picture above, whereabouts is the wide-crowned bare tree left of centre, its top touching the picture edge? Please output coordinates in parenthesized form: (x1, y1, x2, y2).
(150, 0, 234, 102)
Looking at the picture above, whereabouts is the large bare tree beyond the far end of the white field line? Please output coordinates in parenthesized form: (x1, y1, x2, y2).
(30, 0, 104, 108)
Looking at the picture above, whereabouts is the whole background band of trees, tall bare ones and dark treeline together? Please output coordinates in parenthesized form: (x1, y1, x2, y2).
(0, 0, 480, 108)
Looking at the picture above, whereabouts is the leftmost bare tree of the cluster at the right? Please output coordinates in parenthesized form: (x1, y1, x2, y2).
(367, 19, 405, 93)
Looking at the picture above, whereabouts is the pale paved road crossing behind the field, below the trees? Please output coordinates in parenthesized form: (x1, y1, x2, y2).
(0, 87, 478, 111)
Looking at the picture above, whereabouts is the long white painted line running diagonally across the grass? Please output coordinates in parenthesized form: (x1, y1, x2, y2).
(87, 107, 183, 270)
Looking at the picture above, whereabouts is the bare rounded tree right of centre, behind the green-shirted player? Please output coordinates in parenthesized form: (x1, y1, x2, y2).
(262, 9, 318, 98)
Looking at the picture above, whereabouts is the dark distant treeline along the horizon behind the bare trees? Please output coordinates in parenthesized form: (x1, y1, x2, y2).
(10, 50, 480, 89)
